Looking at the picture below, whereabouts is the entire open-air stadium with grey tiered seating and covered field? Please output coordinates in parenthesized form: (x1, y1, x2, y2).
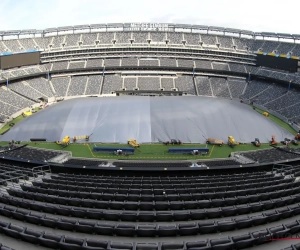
(0, 23, 300, 250)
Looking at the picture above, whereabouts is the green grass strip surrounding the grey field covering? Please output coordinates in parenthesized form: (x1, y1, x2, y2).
(0, 105, 296, 160)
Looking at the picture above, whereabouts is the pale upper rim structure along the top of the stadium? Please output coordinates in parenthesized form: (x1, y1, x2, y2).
(0, 23, 300, 40)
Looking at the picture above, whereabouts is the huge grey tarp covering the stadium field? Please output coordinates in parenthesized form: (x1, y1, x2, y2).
(0, 96, 292, 143)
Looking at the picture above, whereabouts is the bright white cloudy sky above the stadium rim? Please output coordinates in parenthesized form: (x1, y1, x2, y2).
(0, 0, 300, 34)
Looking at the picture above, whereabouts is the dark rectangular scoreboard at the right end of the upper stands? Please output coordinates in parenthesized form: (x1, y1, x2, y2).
(256, 52, 300, 72)
